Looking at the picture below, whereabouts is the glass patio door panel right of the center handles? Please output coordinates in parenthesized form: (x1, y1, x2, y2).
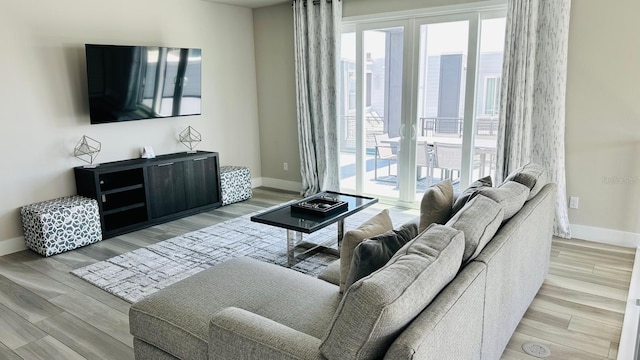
(413, 15, 474, 200)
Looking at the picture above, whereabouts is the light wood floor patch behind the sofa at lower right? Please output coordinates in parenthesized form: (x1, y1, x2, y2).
(502, 238, 635, 360)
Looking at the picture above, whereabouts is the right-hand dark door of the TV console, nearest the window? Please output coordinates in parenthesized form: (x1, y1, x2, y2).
(184, 156, 220, 209)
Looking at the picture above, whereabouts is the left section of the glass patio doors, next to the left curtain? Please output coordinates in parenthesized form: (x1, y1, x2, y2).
(340, 22, 405, 199)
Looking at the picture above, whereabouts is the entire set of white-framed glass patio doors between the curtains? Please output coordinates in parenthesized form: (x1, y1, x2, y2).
(340, 10, 505, 203)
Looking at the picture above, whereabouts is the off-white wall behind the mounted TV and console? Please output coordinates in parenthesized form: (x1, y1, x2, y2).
(0, 0, 261, 254)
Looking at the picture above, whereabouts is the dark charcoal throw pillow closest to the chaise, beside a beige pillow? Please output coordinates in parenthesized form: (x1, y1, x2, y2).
(345, 223, 418, 289)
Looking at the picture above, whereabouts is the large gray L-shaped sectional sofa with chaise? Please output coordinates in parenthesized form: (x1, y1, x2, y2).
(129, 167, 556, 360)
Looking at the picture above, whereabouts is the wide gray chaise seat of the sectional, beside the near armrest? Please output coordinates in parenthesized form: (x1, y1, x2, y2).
(129, 257, 342, 359)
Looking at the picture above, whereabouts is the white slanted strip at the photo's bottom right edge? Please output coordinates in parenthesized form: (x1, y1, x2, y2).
(617, 248, 640, 360)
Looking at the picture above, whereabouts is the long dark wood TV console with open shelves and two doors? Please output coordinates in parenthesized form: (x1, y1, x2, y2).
(74, 151, 222, 239)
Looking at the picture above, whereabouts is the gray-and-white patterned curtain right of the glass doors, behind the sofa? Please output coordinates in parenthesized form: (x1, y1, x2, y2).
(496, 0, 571, 238)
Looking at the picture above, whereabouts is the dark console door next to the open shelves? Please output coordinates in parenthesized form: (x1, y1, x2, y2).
(147, 161, 187, 219)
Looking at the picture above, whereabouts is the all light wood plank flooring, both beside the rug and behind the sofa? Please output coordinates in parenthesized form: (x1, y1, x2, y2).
(0, 189, 634, 360)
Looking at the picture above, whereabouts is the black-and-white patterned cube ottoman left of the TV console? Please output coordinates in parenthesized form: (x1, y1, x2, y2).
(20, 195, 102, 256)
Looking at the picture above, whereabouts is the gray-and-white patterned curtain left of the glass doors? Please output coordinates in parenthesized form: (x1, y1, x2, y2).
(293, 0, 342, 196)
